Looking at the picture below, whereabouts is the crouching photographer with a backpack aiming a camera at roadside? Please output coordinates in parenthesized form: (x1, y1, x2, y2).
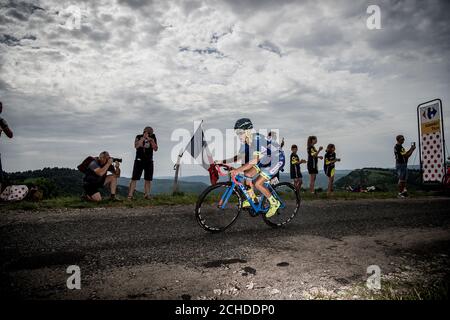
(82, 151, 122, 202)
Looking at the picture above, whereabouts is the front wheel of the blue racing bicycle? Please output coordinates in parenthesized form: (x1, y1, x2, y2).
(195, 182, 242, 232)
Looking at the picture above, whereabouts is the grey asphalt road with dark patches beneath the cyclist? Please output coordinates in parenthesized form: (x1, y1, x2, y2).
(0, 198, 450, 299)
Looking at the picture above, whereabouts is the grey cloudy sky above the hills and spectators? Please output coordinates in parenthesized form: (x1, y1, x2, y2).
(0, 0, 450, 176)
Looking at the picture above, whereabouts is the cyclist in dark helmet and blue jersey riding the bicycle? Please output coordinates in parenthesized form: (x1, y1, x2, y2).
(231, 118, 285, 218)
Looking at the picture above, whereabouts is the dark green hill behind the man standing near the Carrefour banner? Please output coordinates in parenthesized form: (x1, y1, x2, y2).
(335, 168, 421, 191)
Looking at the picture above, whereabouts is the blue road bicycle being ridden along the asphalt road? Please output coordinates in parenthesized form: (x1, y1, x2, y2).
(195, 164, 300, 233)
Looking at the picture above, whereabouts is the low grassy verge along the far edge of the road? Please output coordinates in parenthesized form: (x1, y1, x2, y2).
(0, 191, 439, 210)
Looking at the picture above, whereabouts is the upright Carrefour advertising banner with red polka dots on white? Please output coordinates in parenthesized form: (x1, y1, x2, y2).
(417, 99, 445, 184)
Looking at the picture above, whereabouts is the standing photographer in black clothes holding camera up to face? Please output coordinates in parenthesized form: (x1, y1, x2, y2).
(128, 127, 158, 200)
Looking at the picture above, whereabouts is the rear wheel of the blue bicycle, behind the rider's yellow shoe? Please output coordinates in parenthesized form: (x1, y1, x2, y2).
(262, 182, 300, 228)
